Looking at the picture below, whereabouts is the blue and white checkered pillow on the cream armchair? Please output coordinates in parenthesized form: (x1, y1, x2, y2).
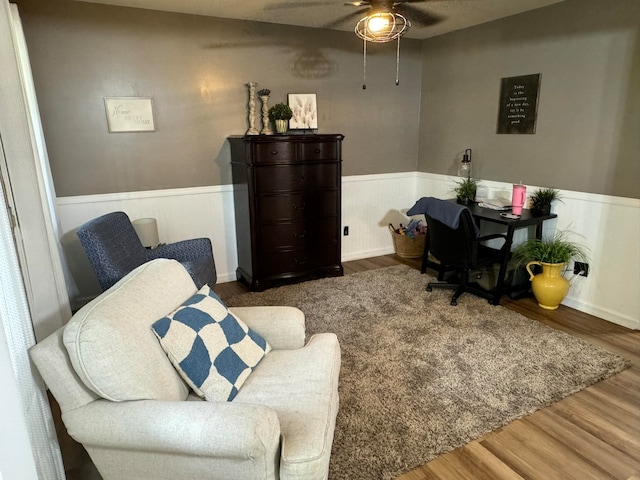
(151, 285, 271, 401)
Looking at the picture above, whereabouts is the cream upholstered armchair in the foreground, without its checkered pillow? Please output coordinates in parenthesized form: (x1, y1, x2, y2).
(30, 259, 340, 480)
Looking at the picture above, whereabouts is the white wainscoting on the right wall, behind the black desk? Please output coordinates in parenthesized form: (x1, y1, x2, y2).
(416, 173, 640, 330)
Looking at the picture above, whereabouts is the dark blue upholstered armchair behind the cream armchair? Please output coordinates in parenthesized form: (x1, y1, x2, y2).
(77, 212, 217, 290)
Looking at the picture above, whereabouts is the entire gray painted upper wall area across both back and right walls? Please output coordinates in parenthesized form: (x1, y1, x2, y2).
(16, 0, 640, 198)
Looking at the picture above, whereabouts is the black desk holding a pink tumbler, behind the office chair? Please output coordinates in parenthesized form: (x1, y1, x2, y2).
(422, 199, 557, 305)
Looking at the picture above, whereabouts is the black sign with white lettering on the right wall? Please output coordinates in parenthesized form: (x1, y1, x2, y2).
(498, 73, 540, 133)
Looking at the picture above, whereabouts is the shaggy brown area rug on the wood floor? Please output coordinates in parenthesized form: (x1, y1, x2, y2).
(227, 265, 630, 480)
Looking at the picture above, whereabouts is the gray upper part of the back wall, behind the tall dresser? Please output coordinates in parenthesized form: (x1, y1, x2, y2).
(16, 0, 421, 196)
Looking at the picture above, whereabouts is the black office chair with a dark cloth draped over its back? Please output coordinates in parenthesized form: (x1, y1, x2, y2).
(407, 198, 509, 305)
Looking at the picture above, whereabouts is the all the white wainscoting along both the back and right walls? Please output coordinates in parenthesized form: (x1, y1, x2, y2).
(58, 172, 640, 329)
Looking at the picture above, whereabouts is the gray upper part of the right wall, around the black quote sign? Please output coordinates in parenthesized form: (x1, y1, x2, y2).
(418, 0, 640, 198)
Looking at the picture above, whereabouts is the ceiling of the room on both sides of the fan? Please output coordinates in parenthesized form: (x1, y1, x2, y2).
(78, 0, 564, 38)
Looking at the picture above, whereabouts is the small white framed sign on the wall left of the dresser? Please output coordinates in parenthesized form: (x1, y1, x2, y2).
(104, 97, 156, 133)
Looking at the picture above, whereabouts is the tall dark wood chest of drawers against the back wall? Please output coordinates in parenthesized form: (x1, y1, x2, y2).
(229, 134, 344, 291)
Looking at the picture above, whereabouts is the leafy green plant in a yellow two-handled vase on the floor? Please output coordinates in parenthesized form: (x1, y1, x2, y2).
(514, 231, 587, 310)
